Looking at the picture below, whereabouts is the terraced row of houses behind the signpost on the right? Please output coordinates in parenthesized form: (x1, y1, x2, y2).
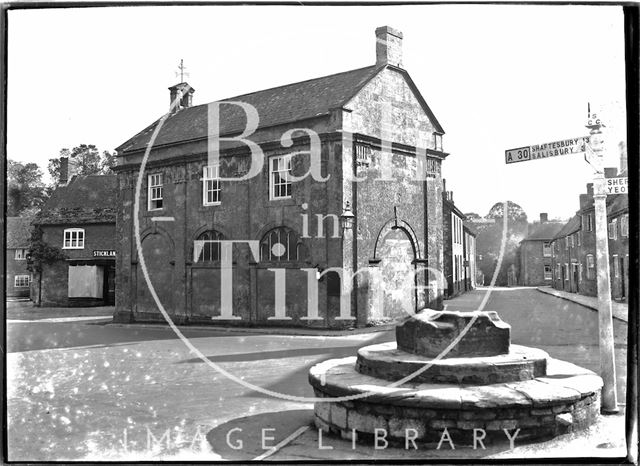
(553, 175, 629, 302)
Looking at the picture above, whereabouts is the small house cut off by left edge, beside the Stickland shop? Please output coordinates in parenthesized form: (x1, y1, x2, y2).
(6, 217, 32, 297)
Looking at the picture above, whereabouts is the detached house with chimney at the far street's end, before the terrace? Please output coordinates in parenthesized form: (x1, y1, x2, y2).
(520, 213, 564, 286)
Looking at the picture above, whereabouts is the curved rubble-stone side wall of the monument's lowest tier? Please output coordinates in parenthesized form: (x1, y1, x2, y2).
(314, 390, 600, 445)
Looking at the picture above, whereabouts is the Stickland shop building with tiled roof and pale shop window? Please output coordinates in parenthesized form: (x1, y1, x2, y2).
(31, 175, 118, 307)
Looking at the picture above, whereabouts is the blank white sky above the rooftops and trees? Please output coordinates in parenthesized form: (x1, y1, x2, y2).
(8, 5, 626, 219)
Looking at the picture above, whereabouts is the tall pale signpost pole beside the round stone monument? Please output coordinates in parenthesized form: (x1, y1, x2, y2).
(587, 115, 618, 413)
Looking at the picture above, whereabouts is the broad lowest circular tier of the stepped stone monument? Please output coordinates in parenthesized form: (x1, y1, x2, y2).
(309, 356, 602, 447)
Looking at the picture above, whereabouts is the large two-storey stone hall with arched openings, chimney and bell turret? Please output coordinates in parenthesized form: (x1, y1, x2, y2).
(115, 27, 447, 328)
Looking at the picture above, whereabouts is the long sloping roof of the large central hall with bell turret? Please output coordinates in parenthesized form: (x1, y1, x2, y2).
(117, 65, 444, 153)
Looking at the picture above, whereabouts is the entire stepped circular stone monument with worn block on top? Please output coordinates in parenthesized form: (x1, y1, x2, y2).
(309, 311, 602, 445)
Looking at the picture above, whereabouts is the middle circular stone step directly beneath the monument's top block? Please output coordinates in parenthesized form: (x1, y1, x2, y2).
(356, 341, 549, 385)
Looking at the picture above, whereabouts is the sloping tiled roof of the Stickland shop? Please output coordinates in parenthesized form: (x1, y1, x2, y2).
(34, 175, 118, 224)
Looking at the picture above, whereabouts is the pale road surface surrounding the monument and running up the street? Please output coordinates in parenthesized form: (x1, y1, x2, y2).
(7, 289, 627, 460)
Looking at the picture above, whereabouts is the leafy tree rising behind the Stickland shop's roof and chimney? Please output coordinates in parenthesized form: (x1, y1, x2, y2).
(47, 144, 115, 184)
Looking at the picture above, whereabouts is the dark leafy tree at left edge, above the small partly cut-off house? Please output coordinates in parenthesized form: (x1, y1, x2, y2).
(7, 160, 46, 216)
